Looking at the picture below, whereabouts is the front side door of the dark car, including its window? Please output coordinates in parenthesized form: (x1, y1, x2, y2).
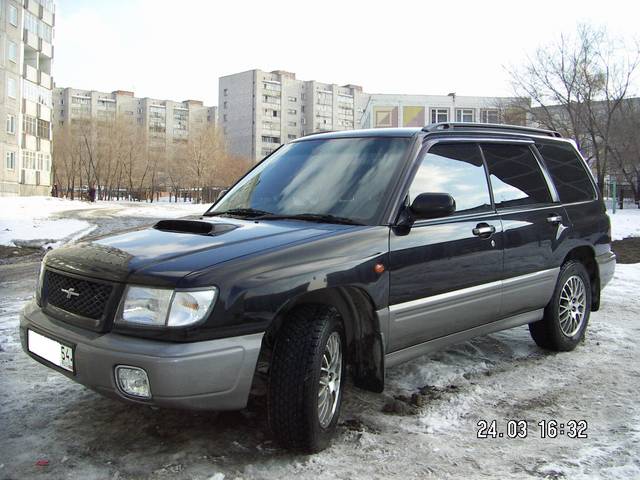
(388, 142, 502, 351)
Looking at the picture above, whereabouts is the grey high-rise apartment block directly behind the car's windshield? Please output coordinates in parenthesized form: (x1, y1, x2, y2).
(218, 70, 366, 160)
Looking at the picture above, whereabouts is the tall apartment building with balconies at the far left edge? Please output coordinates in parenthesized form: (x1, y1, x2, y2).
(0, 0, 55, 196)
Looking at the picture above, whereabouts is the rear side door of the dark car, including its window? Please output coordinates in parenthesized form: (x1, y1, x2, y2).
(481, 142, 566, 317)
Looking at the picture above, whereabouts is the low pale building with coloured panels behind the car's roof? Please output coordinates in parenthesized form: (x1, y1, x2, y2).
(359, 93, 526, 128)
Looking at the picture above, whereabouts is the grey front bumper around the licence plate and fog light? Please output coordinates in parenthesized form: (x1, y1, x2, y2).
(20, 301, 263, 410)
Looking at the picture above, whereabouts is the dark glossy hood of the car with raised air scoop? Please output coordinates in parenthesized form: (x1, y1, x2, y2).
(46, 217, 357, 286)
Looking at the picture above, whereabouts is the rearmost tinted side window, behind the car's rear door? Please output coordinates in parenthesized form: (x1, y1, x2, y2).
(536, 144, 596, 203)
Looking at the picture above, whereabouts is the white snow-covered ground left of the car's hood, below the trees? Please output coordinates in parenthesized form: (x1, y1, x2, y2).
(0, 197, 207, 248)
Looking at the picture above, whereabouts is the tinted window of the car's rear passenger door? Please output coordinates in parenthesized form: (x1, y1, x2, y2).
(482, 144, 551, 208)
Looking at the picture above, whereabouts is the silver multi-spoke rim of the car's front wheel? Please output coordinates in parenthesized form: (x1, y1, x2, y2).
(318, 332, 342, 428)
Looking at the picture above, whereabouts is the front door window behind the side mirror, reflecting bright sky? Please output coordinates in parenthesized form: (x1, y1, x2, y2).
(409, 143, 491, 213)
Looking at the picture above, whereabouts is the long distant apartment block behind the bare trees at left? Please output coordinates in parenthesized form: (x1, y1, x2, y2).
(53, 88, 217, 149)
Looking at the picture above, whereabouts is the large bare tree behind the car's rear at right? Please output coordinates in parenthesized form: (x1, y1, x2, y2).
(509, 25, 640, 189)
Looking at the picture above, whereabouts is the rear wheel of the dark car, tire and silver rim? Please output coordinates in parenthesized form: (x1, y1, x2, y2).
(529, 260, 591, 352)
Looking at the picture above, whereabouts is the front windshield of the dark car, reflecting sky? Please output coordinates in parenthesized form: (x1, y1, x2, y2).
(209, 138, 411, 225)
